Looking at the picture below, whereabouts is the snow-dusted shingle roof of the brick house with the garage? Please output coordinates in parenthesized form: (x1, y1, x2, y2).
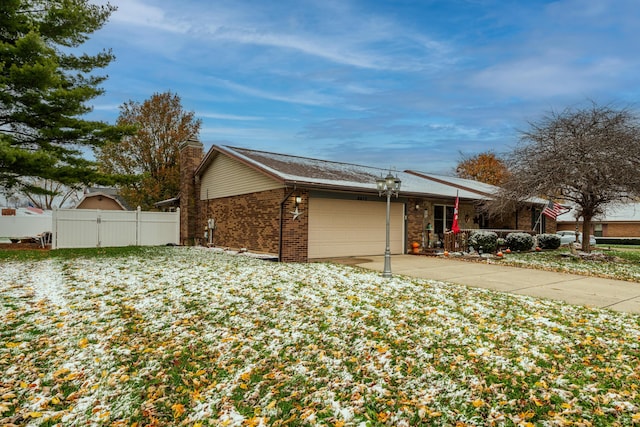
(208, 146, 498, 200)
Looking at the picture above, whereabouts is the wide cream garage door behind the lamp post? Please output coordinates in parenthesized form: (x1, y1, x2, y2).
(309, 197, 404, 258)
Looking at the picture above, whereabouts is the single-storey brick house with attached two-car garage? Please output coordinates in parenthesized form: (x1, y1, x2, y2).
(180, 140, 555, 262)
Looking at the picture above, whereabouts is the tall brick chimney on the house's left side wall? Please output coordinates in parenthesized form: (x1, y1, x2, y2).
(180, 137, 204, 245)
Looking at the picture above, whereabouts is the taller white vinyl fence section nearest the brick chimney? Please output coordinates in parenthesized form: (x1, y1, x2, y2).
(51, 209, 180, 249)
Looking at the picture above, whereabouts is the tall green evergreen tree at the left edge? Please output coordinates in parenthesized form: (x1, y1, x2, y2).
(0, 0, 121, 193)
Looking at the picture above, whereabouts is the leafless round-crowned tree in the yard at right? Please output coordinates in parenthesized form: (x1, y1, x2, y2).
(494, 102, 640, 252)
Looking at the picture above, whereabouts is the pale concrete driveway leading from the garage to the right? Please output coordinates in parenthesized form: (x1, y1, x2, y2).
(348, 255, 640, 313)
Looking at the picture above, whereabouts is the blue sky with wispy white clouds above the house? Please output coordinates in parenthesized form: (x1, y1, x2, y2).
(83, 0, 640, 174)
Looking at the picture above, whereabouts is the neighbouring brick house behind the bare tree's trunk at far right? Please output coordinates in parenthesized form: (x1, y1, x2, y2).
(558, 203, 640, 238)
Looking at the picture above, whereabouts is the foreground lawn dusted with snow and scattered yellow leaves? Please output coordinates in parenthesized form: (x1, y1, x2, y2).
(0, 248, 640, 426)
